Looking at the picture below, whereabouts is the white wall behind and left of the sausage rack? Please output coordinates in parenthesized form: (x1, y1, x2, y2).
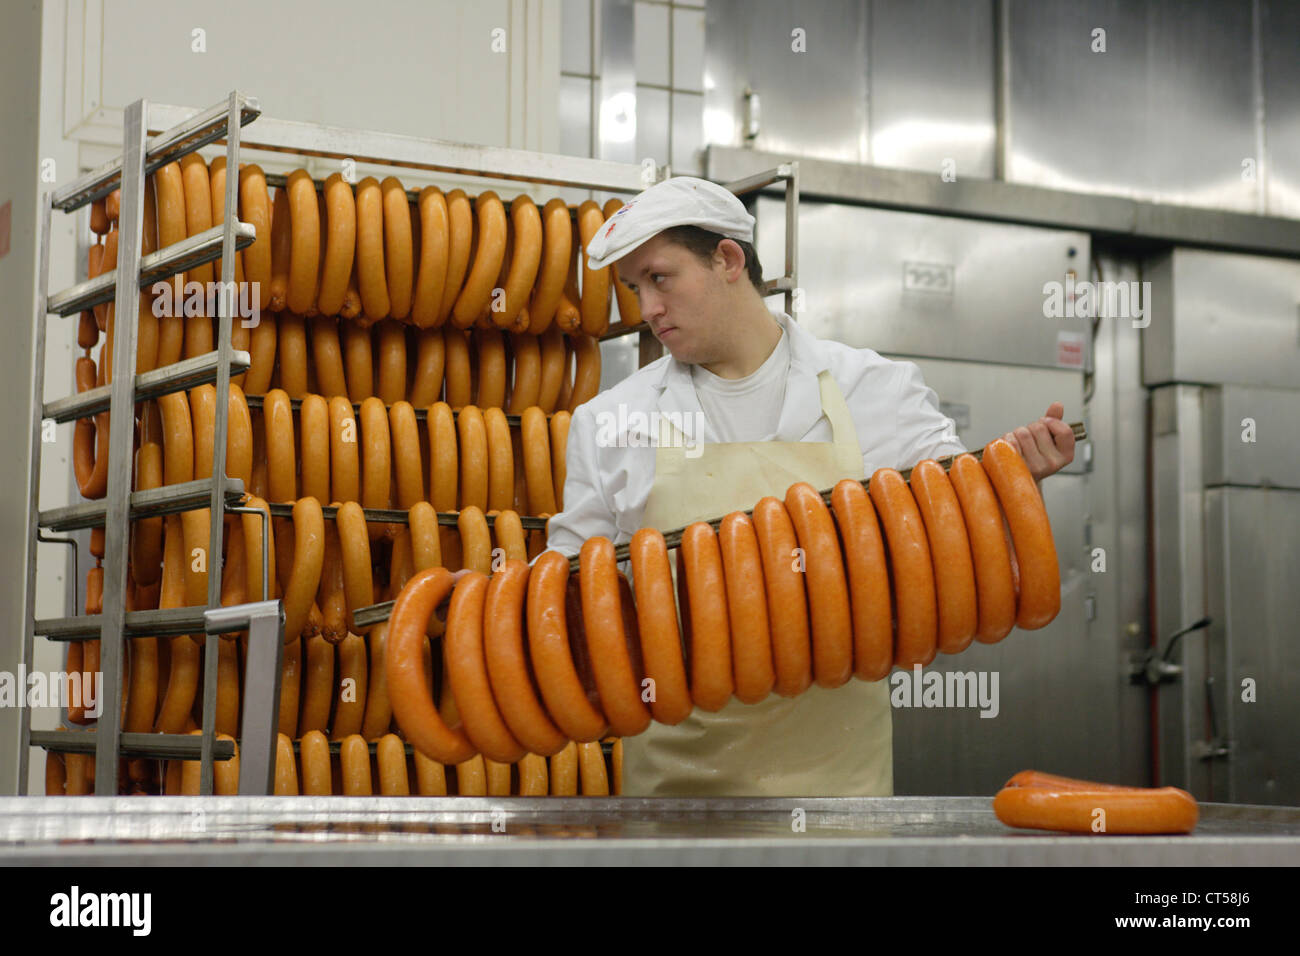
(0, 0, 560, 793)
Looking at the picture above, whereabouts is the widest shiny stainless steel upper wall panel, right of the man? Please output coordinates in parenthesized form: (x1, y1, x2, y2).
(1006, 0, 1258, 212)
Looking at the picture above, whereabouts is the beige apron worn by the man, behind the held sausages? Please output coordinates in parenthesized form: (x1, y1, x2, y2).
(623, 371, 893, 796)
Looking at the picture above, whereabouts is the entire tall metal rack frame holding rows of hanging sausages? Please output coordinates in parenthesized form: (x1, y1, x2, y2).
(27, 91, 798, 796)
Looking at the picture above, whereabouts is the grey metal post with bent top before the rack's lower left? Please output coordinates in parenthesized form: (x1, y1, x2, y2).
(200, 601, 285, 796)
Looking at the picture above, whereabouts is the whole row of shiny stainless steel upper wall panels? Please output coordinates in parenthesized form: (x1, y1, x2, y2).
(705, 0, 1300, 217)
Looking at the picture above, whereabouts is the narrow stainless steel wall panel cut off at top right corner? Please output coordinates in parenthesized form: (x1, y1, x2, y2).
(1257, 0, 1300, 219)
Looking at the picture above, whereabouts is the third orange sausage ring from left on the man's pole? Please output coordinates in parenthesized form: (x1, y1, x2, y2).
(480, 559, 568, 754)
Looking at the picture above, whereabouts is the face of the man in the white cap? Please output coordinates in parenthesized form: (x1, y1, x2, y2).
(614, 235, 729, 364)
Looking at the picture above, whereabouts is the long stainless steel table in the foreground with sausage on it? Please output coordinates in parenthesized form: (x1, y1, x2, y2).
(0, 797, 1300, 866)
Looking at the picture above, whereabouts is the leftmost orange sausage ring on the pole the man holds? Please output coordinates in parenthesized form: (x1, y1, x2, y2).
(385, 567, 475, 763)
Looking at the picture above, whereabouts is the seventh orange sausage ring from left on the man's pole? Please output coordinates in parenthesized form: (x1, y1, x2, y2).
(677, 522, 736, 711)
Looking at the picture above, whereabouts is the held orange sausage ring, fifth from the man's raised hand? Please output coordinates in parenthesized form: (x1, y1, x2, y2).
(831, 479, 893, 680)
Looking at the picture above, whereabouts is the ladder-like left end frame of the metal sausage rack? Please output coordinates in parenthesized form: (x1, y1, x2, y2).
(18, 91, 282, 796)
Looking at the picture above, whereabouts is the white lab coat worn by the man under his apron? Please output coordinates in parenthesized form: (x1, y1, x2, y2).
(546, 313, 967, 555)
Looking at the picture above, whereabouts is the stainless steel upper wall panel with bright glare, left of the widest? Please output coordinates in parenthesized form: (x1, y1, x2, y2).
(866, 0, 997, 179)
